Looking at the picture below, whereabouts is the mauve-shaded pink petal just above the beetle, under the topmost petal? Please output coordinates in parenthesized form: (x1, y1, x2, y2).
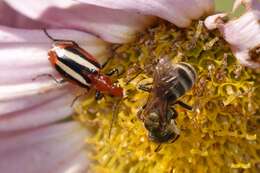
(7, 0, 153, 43)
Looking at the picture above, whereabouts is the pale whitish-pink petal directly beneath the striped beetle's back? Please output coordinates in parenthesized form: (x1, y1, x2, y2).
(0, 26, 110, 85)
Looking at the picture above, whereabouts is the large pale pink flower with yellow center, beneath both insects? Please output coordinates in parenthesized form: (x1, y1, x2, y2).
(0, 0, 259, 173)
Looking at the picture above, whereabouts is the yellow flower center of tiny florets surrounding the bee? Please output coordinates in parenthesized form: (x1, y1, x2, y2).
(76, 21, 260, 173)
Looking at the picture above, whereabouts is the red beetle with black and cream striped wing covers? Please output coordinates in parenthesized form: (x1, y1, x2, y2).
(43, 29, 123, 97)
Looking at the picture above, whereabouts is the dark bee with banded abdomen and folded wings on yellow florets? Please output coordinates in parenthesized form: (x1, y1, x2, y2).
(139, 57, 197, 143)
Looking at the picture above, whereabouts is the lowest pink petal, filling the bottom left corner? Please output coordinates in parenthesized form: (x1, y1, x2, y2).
(0, 122, 89, 173)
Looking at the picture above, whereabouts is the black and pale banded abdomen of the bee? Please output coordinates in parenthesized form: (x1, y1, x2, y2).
(167, 63, 197, 101)
